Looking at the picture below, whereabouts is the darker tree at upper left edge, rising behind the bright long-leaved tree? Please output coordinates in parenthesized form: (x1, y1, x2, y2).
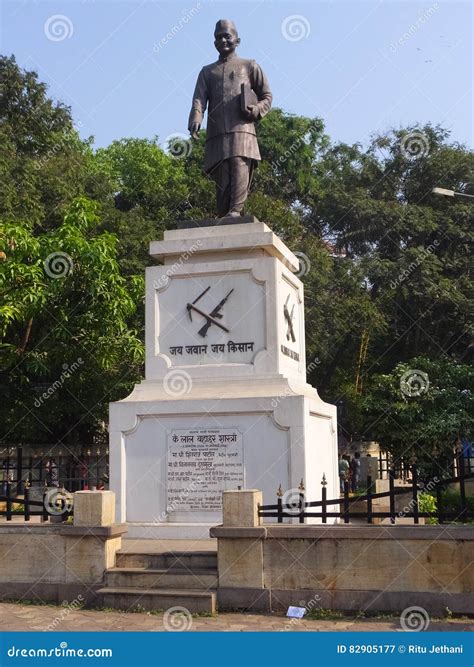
(0, 56, 92, 231)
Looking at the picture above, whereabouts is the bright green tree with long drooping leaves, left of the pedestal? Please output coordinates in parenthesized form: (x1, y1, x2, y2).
(0, 198, 144, 445)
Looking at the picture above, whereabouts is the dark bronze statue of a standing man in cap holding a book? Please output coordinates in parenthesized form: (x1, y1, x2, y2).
(189, 20, 272, 217)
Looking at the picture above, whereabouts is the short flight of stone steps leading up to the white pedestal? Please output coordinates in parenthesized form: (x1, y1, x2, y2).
(97, 551, 217, 614)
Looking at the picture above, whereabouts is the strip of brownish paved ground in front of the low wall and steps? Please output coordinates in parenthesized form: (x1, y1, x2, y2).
(0, 602, 474, 632)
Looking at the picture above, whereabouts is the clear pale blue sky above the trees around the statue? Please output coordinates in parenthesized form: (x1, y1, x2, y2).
(0, 0, 473, 147)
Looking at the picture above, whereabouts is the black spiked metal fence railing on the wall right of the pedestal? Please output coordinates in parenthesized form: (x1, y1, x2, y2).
(258, 466, 474, 524)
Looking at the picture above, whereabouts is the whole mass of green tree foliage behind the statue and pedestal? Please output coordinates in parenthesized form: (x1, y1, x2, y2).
(0, 57, 473, 466)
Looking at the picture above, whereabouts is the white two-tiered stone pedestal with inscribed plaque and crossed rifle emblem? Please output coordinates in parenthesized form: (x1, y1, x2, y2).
(110, 221, 338, 538)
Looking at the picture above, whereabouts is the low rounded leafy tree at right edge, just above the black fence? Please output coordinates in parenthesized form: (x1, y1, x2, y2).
(362, 356, 474, 476)
